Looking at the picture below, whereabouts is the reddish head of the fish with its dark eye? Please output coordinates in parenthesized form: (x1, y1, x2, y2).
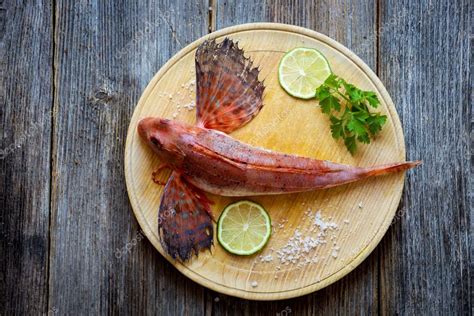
(138, 117, 192, 167)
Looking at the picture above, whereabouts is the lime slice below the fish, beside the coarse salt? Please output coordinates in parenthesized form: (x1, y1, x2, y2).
(217, 200, 272, 256)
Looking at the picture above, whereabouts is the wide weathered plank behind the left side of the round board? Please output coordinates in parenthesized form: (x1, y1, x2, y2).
(49, 1, 208, 315)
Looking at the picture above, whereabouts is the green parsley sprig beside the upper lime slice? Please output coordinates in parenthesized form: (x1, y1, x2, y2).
(316, 74, 387, 154)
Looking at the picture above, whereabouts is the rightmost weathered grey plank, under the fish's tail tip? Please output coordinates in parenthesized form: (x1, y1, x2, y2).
(380, 1, 473, 315)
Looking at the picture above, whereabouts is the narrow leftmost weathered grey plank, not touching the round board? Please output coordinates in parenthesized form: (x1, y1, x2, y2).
(0, 1, 53, 315)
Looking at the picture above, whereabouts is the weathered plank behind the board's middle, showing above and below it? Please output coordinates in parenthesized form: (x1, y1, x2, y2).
(213, 1, 379, 315)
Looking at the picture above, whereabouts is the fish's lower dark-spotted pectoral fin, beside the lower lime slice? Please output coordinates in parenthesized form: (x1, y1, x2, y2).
(158, 171, 214, 261)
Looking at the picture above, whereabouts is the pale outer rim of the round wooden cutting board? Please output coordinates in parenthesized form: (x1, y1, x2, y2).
(124, 23, 406, 301)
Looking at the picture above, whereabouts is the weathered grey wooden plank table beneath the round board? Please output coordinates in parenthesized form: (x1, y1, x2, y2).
(0, 0, 473, 315)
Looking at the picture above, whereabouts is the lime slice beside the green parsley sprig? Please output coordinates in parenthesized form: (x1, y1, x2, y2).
(278, 47, 331, 99)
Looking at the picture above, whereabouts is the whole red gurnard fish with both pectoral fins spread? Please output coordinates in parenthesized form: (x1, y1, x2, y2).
(138, 39, 420, 261)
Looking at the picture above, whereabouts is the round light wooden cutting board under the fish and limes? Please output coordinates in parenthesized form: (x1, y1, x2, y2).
(125, 23, 405, 300)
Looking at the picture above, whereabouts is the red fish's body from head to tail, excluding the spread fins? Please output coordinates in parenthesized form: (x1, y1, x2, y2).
(140, 118, 418, 196)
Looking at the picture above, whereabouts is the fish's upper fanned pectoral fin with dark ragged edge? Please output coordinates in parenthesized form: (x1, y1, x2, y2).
(196, 38, 265, 133)
